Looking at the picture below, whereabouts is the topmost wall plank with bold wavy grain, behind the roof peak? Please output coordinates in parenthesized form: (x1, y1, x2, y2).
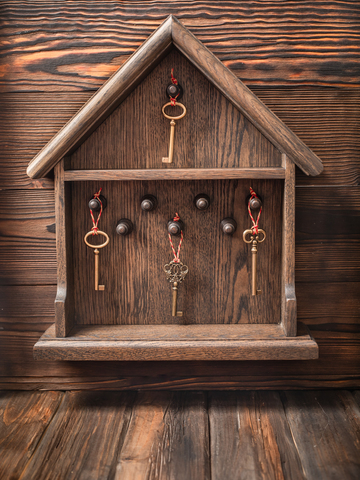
(0, 0, 359, 91)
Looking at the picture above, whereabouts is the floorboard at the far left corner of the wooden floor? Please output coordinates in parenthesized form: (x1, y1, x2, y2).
(0, 392, 64, 479)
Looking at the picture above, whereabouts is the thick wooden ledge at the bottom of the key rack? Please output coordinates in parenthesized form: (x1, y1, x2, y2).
(34, 324, 318, 361)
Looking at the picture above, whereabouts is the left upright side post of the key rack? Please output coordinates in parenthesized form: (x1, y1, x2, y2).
(55, 159, 74, 337)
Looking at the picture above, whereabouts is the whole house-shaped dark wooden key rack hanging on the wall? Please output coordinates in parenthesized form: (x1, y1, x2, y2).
(28, 16, 322, 360)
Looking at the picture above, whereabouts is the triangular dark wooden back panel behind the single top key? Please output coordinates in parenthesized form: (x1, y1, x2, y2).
(66, 49, 281, 176)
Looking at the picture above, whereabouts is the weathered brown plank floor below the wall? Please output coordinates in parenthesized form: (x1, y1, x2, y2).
(0, 390, 360, 480)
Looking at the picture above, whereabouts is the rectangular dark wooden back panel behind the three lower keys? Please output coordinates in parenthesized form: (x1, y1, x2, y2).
(72, 180, 282, 325)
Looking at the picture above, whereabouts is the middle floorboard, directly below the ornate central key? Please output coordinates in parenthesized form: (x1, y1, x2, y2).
(115, 392, 210, 480)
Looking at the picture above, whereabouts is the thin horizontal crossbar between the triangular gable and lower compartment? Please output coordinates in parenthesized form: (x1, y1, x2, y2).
(64, 167, 285, 182)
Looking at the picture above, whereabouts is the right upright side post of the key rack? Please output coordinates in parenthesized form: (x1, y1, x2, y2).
(281, 154, 296, 337)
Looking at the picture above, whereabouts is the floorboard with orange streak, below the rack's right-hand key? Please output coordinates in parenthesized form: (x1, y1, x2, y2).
(209, 392, 306, 480)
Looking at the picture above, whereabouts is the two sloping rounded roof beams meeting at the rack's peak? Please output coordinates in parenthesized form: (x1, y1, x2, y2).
(27, 15, 323, 178)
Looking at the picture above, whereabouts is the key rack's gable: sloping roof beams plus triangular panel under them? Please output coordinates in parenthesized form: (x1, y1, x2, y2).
(27, 16, 323, 178)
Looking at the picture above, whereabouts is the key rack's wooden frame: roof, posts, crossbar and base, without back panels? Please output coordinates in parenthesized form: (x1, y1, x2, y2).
(28, 16, 322, 360)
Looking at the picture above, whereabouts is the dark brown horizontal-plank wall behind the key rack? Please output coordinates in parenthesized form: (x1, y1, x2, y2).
(0, 0, 360, 389)
